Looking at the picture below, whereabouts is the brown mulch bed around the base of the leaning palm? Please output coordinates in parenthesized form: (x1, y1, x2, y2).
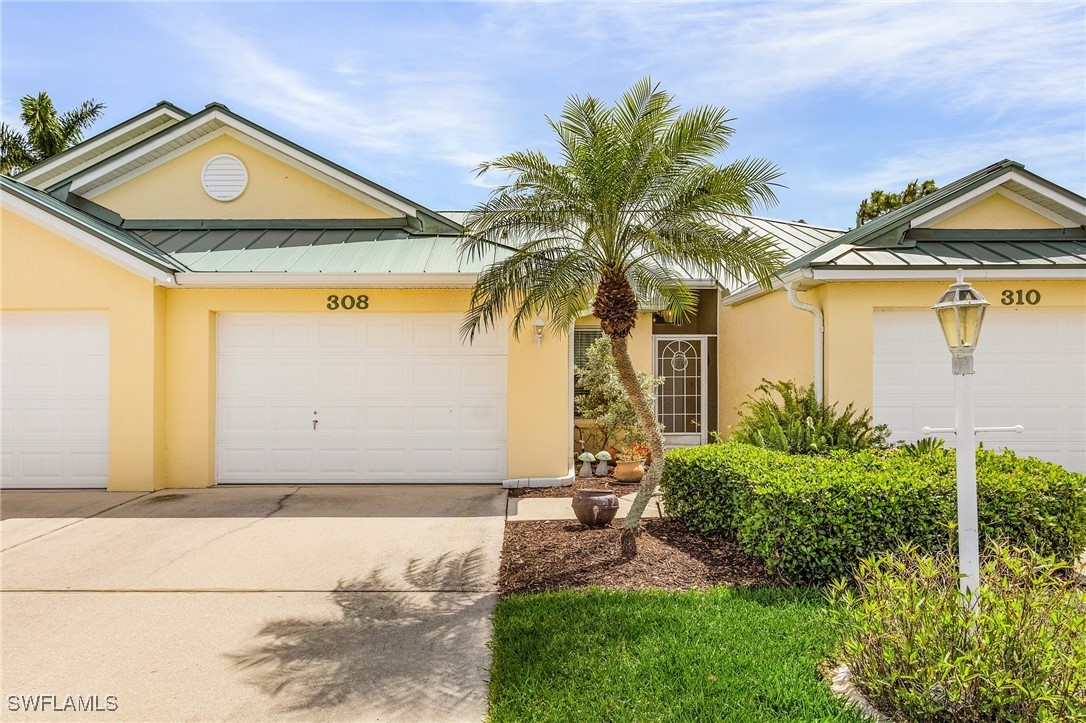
(497, 514, 772, 597)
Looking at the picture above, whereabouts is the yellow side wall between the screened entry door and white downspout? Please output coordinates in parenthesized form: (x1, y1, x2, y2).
(717, 287, 823, 436)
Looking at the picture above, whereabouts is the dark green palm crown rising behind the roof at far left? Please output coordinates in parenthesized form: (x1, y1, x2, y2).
(0, 91, 105, 175)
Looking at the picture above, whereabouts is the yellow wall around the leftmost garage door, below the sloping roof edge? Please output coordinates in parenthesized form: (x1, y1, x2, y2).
(0, 208, 166, 490)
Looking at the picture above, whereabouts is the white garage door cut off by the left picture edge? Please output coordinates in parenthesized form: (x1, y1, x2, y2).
(0, 312, 110, 487)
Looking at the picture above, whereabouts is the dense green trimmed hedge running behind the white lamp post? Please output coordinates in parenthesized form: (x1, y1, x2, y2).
(661, 442, 1086, 583)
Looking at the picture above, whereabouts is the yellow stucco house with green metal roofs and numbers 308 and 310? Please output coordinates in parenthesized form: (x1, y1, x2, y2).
(0, 103, 1086, 490)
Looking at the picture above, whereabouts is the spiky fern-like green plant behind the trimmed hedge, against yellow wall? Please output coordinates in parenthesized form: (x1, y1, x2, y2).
(732, 379, 889, 455)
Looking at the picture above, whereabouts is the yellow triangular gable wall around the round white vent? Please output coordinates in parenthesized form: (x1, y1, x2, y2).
(93, 130, 388, 219)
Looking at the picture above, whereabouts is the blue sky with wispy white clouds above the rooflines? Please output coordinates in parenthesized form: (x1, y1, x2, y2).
(0, 1, 1086, 228)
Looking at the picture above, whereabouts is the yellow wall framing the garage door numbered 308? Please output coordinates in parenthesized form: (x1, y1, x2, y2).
(165, 289, 571, 487)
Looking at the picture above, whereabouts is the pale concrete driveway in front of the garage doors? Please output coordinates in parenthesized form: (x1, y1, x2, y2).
(0, 485, 505, 721)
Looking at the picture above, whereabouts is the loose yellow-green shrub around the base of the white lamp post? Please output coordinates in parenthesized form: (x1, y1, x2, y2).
(830, 546, 1086, 722)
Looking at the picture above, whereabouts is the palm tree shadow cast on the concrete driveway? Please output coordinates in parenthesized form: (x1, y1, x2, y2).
(227, 548, 496, 720)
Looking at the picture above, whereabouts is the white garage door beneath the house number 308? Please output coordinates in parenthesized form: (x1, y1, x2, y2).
(216, 312, 506, 483)
